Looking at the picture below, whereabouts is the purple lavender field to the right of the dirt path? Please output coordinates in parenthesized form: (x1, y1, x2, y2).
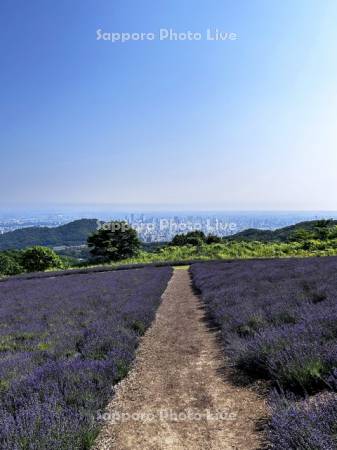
(191, 257, 337, 450)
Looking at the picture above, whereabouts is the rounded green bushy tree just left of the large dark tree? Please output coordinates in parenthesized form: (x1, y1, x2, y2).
(21, 246, 63, 272)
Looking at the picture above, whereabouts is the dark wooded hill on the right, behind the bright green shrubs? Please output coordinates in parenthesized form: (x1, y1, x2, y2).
(226, 219, 337, 242)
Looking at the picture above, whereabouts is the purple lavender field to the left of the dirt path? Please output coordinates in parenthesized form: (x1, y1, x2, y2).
(0, 268, 171, 450)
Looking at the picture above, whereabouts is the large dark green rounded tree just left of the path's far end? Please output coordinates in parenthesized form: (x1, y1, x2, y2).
(88, 221, 140, 261)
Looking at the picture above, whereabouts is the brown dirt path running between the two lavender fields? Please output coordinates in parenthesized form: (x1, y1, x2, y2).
(96, 270, 266, 450)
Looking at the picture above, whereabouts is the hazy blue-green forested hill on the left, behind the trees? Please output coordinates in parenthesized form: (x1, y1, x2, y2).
(0, 219, 97, 250)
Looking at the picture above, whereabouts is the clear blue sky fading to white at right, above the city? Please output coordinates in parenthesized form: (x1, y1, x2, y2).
(0, 0, 337, 210)
